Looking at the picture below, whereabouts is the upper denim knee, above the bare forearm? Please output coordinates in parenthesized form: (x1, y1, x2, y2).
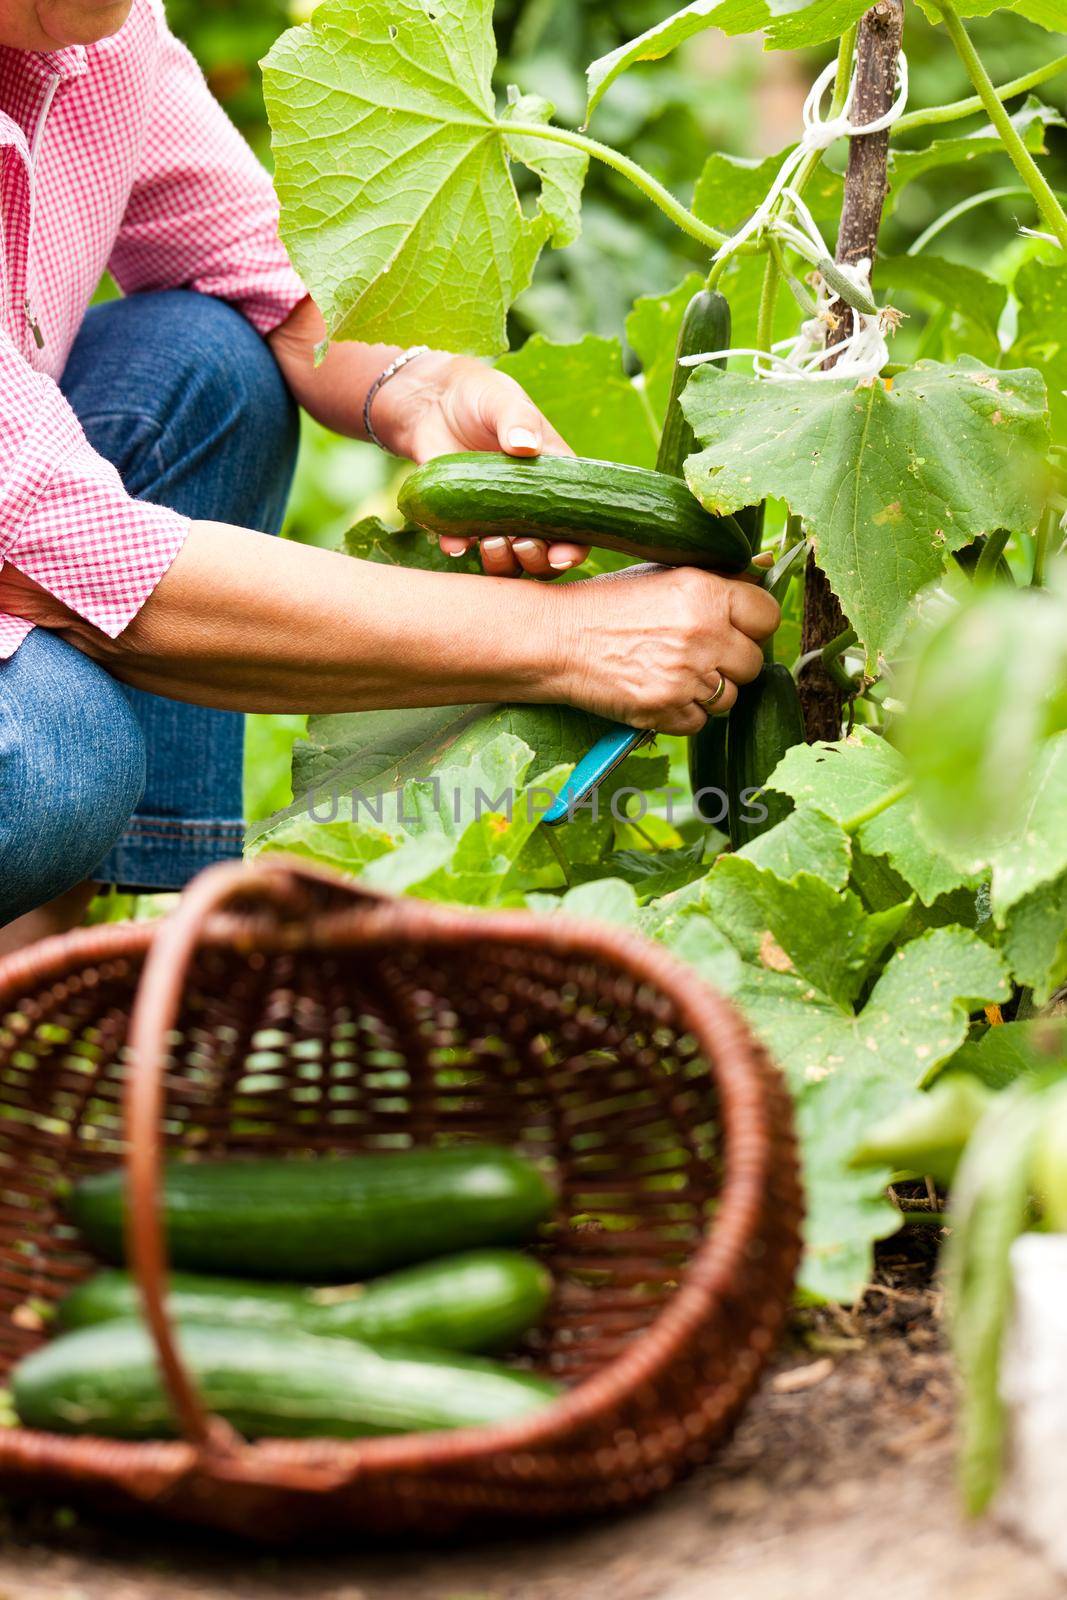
(62, 290, 299, 533)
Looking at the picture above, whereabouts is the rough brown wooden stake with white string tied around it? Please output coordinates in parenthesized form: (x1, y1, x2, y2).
(800, 0, 904, 744)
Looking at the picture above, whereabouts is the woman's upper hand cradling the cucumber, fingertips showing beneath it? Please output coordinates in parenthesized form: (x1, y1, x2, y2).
(373, 350, 589, 578)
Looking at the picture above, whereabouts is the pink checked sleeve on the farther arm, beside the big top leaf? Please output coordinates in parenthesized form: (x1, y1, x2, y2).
(110, 6, 307, 333)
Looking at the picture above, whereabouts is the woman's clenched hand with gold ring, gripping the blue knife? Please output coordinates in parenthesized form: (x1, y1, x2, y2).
(552, 566, 781, 733)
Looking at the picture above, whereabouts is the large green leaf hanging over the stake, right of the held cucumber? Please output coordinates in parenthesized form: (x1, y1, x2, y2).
(683, 357, 1048, 666)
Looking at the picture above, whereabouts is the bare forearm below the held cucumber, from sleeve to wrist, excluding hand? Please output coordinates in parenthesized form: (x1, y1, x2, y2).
(0, 523, 565, 712)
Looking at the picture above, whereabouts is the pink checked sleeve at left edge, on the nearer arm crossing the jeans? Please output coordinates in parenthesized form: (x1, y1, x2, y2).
(0, 334, 189, 659)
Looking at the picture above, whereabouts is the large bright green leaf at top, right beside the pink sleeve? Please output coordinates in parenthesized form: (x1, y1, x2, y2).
(264, 0, 585, 354)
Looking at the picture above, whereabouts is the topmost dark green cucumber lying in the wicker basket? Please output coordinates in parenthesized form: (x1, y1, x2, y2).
(67, 1144, 553, 1283)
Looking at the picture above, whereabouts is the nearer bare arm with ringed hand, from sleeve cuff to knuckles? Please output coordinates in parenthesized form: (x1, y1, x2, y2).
(0, 523, 779, 733)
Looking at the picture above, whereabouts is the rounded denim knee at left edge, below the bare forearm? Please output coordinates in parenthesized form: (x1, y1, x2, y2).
(0, 629, 146, 925)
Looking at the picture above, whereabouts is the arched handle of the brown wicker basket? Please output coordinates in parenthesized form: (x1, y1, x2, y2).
(123, 856, 363, 1454)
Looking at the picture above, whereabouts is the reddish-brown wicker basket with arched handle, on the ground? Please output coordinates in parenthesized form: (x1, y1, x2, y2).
(0, 858, 801, 1539)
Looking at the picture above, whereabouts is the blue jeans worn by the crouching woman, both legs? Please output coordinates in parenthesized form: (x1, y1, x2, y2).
(0, 290, 299, 925)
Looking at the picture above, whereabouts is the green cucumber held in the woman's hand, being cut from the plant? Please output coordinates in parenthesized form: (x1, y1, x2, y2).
(397, 451, 750, 573)
